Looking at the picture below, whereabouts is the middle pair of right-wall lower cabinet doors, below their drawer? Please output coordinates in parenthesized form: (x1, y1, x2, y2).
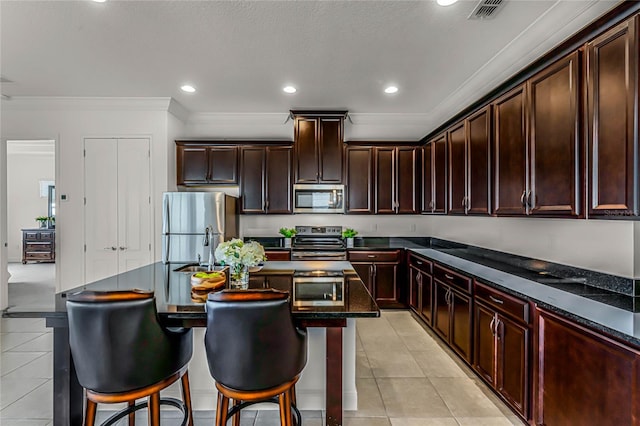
(433, 279, 472, 363)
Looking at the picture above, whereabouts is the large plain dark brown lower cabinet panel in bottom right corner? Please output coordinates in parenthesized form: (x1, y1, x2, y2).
(534, 308, 640, 426)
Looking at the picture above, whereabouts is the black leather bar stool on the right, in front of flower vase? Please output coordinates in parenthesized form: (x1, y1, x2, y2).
(205, 289, 307, 426)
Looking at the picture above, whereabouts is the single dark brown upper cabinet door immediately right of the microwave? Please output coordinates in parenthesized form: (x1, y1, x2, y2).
(346, 146, 375, 213)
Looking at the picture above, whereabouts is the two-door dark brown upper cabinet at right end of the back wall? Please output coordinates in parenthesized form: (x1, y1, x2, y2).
(374, 146, 420, 214)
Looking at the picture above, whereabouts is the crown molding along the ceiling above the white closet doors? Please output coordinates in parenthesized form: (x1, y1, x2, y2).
(2, 96, 172, 111)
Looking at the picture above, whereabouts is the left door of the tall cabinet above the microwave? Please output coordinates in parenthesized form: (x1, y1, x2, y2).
(294, 117, 320, 183)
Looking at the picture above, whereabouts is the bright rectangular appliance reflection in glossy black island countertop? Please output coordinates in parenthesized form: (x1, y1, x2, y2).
(293, 276, 344, 306)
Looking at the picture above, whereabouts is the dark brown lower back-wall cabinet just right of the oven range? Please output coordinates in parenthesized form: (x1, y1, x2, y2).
(348, 250, 405, 308)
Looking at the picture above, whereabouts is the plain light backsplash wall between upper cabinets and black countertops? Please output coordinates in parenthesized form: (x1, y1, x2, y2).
(240, 214, 640, 278)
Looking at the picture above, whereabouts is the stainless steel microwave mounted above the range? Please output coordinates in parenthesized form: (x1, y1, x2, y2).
(293, 184, 344, 213)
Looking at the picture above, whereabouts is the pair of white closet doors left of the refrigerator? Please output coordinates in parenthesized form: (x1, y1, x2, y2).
(85, 139, 152, 282)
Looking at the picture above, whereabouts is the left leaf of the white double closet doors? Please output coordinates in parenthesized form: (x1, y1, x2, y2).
(84, 139, 118, 282)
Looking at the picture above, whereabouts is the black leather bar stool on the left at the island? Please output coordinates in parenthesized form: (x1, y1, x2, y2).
(67, 290, 193, 426)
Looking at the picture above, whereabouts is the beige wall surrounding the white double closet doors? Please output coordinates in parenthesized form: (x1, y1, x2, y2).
(0, 98, 175, 291)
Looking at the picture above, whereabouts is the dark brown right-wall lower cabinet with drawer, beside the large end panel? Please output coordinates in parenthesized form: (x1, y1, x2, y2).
(473, 282, 531, 419)
